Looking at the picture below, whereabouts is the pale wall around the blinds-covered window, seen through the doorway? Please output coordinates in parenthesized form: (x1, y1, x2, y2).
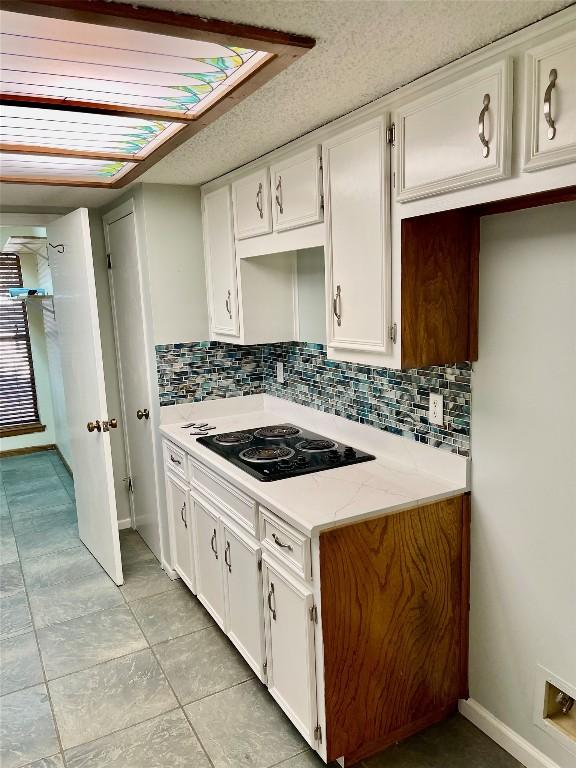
(0, 225, 56, 451)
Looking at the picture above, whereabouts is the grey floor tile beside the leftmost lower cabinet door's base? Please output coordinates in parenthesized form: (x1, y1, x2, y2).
(130, 582, 214, 645)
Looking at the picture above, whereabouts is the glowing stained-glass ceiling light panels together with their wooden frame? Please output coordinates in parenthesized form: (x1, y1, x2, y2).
(0, 0, 313, 186)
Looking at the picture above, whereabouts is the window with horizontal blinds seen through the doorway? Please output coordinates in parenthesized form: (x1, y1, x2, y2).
(0, 253, 43, 437)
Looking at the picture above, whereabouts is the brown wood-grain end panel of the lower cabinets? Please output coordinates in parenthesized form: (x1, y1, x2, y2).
(320, 496, 468, 760)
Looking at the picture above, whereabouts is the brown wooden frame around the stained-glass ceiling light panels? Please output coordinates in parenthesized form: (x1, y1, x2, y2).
(0, 0, 315, 189)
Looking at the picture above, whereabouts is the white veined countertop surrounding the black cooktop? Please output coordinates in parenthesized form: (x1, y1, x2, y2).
(160, 395, 469, 536)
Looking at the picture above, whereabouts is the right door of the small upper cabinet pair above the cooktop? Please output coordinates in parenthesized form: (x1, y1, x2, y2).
(270, 147, 322, 231)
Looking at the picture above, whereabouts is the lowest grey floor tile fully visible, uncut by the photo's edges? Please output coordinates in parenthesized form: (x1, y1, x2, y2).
(49, 650, 177, 749)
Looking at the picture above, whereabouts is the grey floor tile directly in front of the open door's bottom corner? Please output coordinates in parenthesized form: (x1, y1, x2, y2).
(28, 572, 123, 628)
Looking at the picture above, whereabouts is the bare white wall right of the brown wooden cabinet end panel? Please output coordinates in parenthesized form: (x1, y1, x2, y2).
(470, 203, 576, 768)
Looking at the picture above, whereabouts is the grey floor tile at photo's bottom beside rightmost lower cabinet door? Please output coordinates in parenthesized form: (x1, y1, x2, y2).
(185, 680, 307, 768)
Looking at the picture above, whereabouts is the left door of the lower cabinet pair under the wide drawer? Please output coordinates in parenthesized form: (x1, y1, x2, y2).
(193, 498, 226, 631)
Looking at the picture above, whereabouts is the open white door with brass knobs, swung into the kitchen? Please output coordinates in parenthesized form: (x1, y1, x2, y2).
(47, 208, 124, 584)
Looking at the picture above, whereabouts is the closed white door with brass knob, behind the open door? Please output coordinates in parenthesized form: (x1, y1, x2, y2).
(106, 213, 161, 559)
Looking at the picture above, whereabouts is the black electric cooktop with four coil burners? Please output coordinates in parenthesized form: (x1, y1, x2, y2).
(198, 424, 374, 481)
